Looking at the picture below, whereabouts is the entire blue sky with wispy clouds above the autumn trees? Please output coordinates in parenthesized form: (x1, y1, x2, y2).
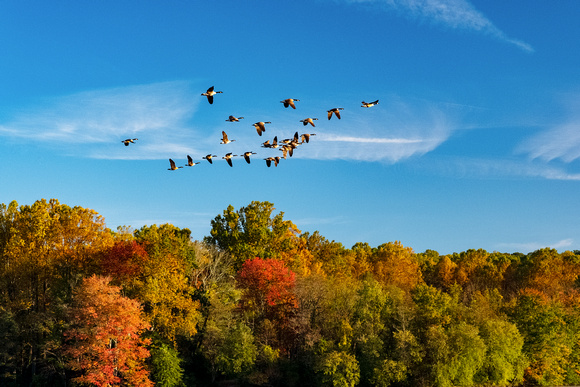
(0, 0, 580, 254)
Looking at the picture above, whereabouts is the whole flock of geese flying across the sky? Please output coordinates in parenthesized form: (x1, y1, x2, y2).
(121, 86, 379, 171)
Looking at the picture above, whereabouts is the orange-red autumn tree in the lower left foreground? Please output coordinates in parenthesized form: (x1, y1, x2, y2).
(63, 276, 153, 386)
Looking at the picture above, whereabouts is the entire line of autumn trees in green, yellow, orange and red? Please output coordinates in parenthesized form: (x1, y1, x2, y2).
(0, 199, 580, 387)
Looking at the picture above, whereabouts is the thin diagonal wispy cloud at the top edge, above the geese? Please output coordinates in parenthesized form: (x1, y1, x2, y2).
(347, 0, 534, 52)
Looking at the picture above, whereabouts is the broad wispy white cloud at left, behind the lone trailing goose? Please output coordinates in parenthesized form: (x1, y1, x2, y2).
(0, 82, 204, 159)
